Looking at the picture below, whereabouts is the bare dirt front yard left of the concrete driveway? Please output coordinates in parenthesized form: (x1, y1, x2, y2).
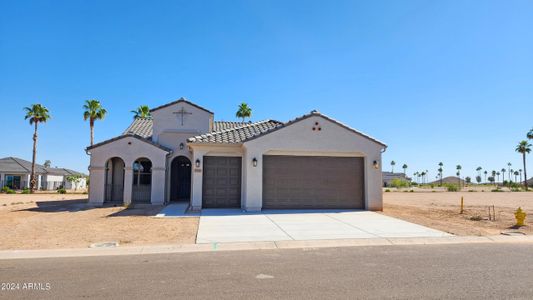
(0, 194, 198, 250)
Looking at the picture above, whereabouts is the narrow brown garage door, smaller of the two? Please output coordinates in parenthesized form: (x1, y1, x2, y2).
(202, 156, 242, 208)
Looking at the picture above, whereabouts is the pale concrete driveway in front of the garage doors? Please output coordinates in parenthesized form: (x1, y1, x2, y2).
(196, 209, 450, 243)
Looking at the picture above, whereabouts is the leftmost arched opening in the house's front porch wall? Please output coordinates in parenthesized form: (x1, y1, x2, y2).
(104, 157, 126, 203)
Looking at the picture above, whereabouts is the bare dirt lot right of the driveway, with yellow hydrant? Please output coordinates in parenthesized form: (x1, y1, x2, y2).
(383, 192, 533, 236)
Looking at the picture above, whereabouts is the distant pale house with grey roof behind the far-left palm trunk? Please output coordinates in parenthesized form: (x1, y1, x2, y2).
(0, 157, 87, 190)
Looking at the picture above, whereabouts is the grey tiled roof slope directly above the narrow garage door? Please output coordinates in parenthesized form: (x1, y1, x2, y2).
(187, 120, 283, 144)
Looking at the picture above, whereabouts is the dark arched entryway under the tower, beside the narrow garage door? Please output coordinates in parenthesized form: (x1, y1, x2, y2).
(170, 156, 191, 202)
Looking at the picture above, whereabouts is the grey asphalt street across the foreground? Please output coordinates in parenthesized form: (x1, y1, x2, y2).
(0, 243, 533, 299)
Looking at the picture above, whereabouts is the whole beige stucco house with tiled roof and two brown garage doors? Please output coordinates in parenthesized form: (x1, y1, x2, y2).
(86, 98, 386, 211)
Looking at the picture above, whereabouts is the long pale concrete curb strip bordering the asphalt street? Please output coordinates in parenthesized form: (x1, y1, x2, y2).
(0, 235, 533, 260)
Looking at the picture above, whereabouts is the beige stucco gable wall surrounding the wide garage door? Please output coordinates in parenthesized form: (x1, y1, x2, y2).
(242, 116, 384, 210)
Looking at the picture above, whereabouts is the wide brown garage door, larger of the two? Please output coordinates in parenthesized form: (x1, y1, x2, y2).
(263, 155, 365, 209)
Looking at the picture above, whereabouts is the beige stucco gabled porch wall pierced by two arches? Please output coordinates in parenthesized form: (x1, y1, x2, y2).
(89, 137, 167, 205)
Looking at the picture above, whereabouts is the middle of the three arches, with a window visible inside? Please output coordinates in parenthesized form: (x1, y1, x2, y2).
(131, 158, 152, 204)
